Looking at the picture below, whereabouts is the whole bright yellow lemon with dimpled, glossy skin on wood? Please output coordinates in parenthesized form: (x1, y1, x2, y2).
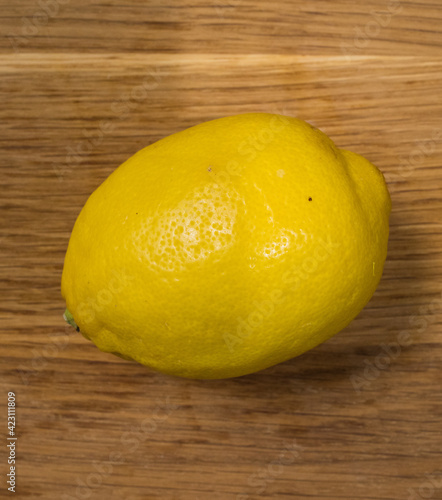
(62, 113, 391, 379)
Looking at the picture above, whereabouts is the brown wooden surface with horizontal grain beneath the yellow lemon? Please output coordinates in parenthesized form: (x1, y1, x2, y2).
(0, 0, 442, 500)
